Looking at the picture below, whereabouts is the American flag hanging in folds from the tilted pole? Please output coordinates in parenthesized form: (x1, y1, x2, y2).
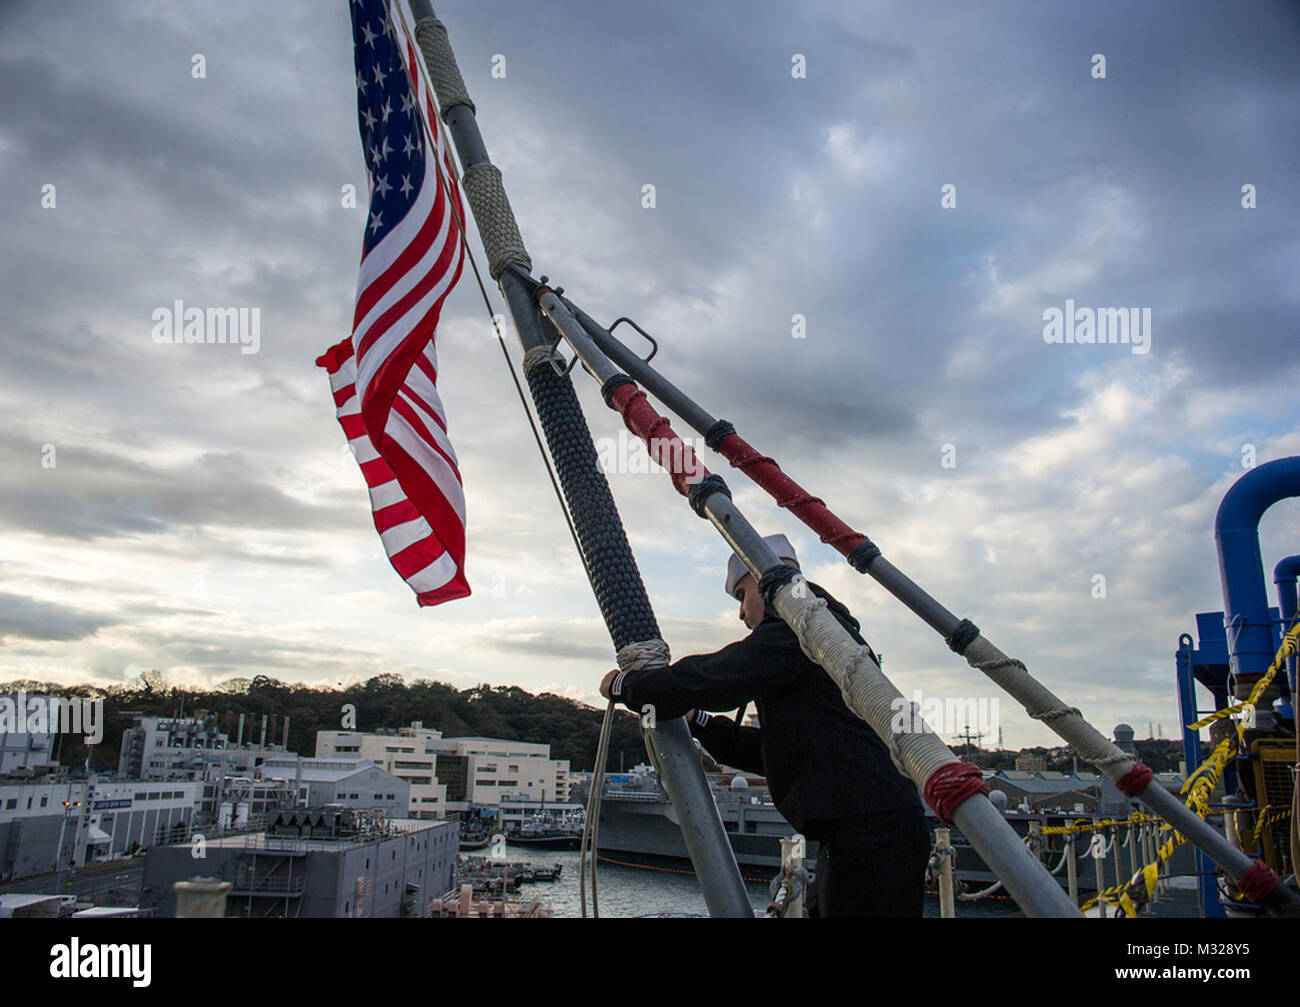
(316, 0, 469, 605)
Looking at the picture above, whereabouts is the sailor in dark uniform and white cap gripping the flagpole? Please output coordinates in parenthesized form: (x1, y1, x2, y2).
(601, 535, 930, 917)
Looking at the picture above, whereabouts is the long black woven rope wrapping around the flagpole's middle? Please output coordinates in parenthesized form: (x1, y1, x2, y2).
(524, 360, 660, 650)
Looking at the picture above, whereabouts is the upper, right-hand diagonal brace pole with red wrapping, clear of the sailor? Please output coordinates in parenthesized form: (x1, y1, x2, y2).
(547, 299, 1300, 913)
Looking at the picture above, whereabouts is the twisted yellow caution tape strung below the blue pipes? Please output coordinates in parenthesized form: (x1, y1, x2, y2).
(1076, 621, 1300, 917)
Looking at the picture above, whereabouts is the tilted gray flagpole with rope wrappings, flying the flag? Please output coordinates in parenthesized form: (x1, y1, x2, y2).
(411, 0, 754, 917)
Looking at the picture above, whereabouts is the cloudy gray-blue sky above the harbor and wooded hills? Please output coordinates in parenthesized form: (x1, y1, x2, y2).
(0, 0, 1300, 747)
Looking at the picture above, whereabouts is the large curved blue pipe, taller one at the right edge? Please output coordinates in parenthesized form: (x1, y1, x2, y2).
(1214, 457, 1300, 698)
